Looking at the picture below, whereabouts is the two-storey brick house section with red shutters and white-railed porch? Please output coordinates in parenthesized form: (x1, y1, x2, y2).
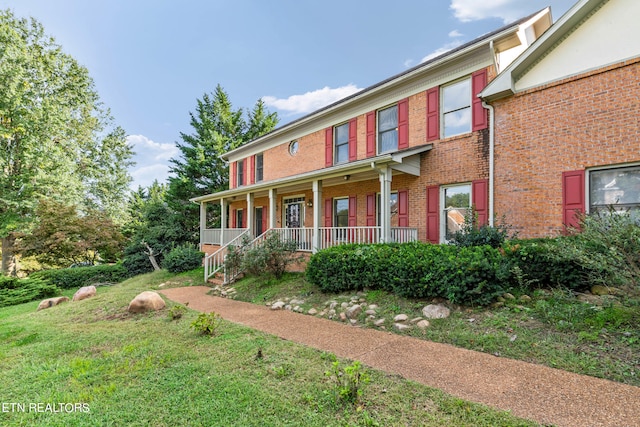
(192, 8, 552, 275)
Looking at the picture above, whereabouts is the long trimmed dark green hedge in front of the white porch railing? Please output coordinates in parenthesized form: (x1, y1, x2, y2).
(307, 242, 510, 305)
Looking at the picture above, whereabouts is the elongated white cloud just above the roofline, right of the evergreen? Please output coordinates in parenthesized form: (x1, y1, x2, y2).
(262, 84, 362, 114)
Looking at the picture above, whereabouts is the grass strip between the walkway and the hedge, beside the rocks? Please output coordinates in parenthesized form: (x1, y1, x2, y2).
(234, 274, 640, 386)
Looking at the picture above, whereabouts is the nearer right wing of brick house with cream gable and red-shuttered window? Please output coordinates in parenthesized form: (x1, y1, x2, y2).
(481, 0, 640, 237)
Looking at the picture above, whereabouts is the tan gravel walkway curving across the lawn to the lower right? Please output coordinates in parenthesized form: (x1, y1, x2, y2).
(160, 286, 640, 427)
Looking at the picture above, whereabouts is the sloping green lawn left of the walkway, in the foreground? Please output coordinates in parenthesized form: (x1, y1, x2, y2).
(0, 271, 536, 427)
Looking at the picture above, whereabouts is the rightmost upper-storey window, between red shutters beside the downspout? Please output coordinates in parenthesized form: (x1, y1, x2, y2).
(441, 78, 471, 138)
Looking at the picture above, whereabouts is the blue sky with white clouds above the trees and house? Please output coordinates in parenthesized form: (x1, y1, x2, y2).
(0, 0, 577, 188)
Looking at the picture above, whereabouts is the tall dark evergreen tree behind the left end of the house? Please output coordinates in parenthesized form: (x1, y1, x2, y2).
(167, 85, 278, 243)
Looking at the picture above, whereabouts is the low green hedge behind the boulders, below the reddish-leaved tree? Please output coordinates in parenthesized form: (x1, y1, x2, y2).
(29, 264, 131, 289)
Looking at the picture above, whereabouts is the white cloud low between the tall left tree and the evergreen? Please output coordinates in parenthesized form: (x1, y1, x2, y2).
(127, 135, 180, 190)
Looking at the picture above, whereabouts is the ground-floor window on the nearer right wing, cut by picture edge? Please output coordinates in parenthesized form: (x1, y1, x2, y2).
(587, 165, 640, 214)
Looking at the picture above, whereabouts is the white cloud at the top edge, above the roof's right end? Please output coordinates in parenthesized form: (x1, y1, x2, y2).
(449, 0, 531, 24)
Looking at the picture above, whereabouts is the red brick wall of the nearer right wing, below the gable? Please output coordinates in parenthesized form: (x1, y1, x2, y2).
(494, 59, 640, 237)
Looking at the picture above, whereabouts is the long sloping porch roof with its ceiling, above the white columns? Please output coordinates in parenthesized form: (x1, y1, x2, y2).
(190, 144, 433, 203)
